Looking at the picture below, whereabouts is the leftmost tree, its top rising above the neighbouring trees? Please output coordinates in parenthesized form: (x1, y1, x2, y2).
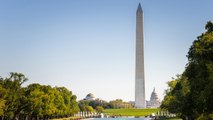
(1, 72, 28, 119)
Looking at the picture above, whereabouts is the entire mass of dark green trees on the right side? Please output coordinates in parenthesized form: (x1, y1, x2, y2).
(161, 21, 213, 119)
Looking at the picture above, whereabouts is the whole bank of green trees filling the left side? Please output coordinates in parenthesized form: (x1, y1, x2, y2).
(0, 73, 79, 120)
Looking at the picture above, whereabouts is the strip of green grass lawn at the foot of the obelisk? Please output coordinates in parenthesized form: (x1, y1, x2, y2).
(103, 108, 159, 116)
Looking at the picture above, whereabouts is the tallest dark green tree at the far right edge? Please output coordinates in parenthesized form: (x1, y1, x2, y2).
(184, 21, 213, 118)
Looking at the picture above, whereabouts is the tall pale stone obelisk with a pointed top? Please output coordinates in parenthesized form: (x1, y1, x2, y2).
(135, 3, 146, 108)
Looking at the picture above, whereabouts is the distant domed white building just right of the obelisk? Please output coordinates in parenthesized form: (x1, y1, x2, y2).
(146, 88, 161, 108)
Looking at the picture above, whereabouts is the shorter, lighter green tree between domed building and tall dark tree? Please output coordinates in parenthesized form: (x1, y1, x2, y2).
(161, 75, 190, 116)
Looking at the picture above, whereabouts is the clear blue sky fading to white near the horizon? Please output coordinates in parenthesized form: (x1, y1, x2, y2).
(0, 0, 213, 101)
